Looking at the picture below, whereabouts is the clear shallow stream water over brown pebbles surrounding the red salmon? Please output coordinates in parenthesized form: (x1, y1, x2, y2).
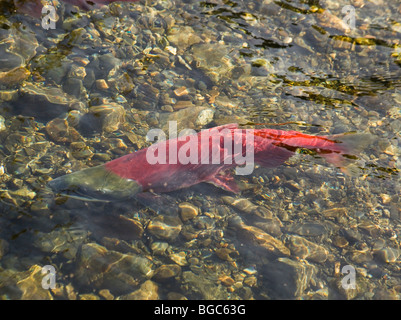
(0, 0, 401, 299)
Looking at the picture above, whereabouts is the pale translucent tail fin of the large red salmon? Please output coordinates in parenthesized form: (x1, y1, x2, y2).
(319, 133, 374, 176)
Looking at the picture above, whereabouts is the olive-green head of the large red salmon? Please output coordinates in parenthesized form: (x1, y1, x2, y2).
(48, 165, 142, 202)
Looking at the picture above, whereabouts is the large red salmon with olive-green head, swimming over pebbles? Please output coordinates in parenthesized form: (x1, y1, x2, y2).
(49, 124, 351, 199)
